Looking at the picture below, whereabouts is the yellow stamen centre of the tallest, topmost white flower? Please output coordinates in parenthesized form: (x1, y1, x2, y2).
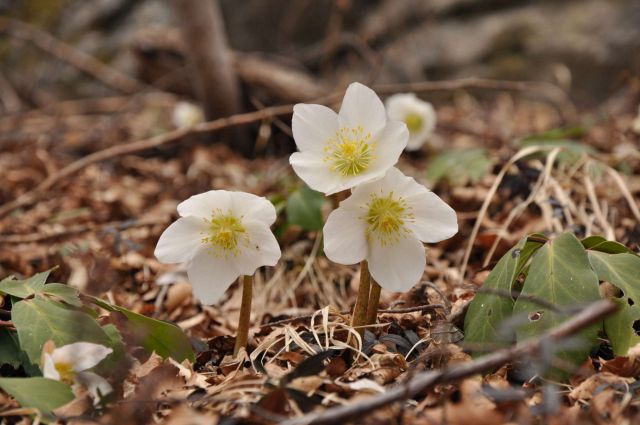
(323, 126, 376, 177)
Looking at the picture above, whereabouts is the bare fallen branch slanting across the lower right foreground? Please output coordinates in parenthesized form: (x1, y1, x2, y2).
(281, 300, 616, 425)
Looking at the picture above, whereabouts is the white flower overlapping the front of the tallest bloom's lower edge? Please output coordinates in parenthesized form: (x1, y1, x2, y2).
(323, 168, 458, 292)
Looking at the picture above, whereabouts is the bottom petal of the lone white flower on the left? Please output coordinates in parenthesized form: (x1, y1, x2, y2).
(187, 249, 240, 305)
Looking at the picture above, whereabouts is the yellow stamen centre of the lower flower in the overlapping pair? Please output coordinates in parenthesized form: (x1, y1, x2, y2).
(364, 192, 414, 245)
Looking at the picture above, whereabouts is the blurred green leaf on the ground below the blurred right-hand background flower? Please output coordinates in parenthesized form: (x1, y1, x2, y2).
(427, 149, 493, 185)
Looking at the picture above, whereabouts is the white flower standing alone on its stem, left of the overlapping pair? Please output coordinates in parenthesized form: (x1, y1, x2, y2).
(155, 190, 280, 304)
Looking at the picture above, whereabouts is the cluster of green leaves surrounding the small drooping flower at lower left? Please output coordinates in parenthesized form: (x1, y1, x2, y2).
(0, 270, 194, 420)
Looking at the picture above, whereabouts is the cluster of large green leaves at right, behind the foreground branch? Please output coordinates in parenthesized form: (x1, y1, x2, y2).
(465, 233, 640, 377)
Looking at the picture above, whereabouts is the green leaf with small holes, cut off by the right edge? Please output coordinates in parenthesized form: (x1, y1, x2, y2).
(589, 251, 640, 356)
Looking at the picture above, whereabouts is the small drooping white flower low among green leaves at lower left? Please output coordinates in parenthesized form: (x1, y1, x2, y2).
(42, 342, 113, 402)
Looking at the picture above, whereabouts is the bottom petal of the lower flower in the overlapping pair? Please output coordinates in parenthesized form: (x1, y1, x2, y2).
(368, 237, 426, 292)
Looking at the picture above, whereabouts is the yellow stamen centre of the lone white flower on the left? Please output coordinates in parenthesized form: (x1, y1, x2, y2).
(202, 210, 249, 257)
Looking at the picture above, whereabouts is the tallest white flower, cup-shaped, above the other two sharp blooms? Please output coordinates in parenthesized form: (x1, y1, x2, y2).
(290, 83, 409, 195)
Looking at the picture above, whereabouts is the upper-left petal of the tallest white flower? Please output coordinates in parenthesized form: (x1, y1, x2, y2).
(291, 103, 340, 155)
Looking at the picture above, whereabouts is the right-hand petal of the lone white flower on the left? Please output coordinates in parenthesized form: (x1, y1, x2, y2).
(229, 220, 281, 276)
